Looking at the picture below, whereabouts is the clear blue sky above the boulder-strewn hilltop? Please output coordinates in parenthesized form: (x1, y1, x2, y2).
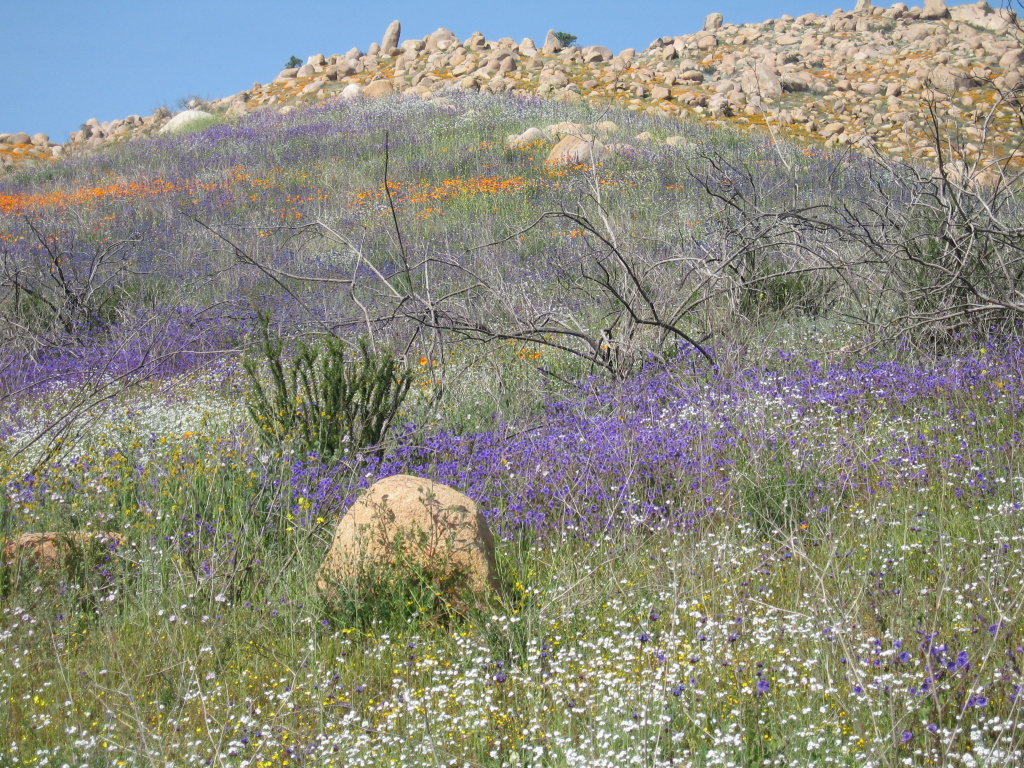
(0, 0, 843, 141)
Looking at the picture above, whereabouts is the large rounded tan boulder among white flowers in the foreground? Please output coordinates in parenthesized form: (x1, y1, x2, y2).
(316, 475, 499, 597)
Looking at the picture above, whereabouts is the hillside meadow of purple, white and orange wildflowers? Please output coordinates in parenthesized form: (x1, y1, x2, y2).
(0, 94, 1024, 768)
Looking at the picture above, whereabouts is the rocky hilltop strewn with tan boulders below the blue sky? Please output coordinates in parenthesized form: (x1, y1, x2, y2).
(0, 0, 1024, 173)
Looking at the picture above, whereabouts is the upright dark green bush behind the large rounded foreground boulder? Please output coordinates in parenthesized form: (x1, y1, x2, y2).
(243, 322, 412, 459)
